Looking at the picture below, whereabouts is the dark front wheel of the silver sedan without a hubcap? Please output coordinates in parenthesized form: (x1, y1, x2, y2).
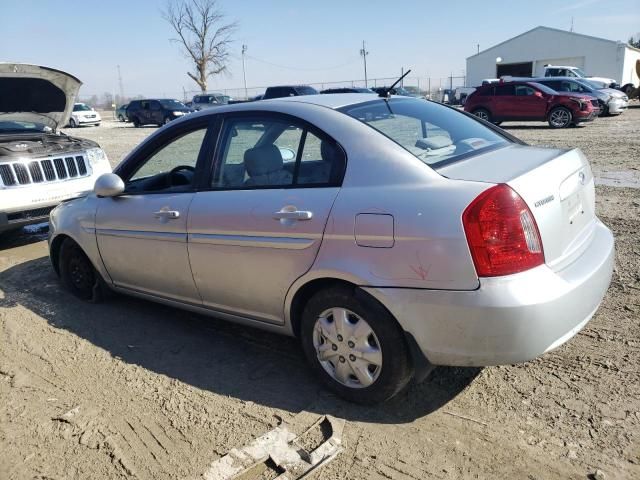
(58, 238, 107, 303)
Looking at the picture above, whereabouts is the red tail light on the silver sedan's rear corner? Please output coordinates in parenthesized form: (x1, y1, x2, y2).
(462, 184, 544, 277)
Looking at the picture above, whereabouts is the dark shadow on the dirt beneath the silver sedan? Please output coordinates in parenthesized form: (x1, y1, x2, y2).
(0, 257, 481, 423)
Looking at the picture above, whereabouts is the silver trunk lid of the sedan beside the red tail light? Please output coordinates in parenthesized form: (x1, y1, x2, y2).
(437, 145, 596, 271)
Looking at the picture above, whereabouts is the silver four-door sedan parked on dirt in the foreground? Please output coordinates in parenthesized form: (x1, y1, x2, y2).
(49, 94, 614, 403)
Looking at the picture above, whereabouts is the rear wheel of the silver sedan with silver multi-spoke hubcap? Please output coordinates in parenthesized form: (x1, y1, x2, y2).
(300, 287, 413, 404)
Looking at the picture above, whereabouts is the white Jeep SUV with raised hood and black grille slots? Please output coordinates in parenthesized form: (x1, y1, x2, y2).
(0, 63, 111, 233)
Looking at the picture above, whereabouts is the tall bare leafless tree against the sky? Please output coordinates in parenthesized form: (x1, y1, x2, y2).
(162, 0, 238, 92)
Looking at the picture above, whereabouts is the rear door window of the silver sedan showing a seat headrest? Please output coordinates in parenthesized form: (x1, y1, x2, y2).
(211, 118, 345, 189)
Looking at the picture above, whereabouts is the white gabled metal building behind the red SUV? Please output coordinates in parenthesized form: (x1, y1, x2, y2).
(467, 27, 640, 87)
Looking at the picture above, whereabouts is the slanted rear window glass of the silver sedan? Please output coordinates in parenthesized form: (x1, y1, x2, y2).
(340, 98, 510, 166)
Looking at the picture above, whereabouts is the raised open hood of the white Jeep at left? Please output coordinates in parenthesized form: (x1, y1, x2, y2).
(0, 63, 82, 130)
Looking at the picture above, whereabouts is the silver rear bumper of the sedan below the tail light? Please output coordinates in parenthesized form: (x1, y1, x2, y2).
(363, 221, 614, 366)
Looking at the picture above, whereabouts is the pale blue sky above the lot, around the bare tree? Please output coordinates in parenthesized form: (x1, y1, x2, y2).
(0, 0, 640, 98)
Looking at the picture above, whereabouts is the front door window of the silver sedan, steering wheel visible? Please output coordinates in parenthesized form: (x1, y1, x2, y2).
(127, 127, 207, 191)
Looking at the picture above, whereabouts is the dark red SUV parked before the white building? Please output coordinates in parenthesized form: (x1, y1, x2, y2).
(464, 82, 600, 128)
